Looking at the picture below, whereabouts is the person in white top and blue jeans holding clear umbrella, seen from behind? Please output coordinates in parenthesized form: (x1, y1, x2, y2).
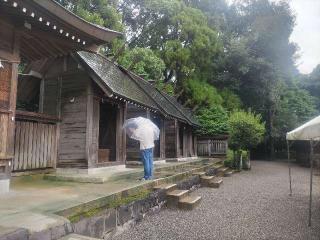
(124, 117, 160, 180)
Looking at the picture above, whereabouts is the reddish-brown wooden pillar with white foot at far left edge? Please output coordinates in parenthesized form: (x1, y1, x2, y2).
(0, 29, 20, 193)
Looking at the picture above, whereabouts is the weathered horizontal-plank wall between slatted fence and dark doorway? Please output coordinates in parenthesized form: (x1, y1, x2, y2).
(58, 72, 90, 168)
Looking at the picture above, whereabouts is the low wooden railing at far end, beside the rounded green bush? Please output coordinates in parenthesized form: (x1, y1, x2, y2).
(197, 139, 228, 156)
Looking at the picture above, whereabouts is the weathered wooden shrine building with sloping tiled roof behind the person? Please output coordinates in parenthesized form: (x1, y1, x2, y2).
(13, 51, 197, 171)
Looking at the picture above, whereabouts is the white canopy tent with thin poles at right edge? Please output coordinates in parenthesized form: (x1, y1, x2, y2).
(286, 116, 320, 226)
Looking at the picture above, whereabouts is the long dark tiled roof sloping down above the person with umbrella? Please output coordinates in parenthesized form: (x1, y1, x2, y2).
(78, 52, 199, 126)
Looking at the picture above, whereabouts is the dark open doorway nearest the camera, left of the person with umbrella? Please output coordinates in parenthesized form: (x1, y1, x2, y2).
(98, 103, 118, 163)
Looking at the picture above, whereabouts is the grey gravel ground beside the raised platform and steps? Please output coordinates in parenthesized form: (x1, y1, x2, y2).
(115, 161, 320, 240)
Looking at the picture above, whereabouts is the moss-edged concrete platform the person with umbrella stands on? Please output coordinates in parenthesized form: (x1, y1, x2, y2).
(0, 159, 221, 239)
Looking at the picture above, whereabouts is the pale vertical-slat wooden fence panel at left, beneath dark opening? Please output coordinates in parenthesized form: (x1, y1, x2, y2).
(12, 121, 57, 171)
